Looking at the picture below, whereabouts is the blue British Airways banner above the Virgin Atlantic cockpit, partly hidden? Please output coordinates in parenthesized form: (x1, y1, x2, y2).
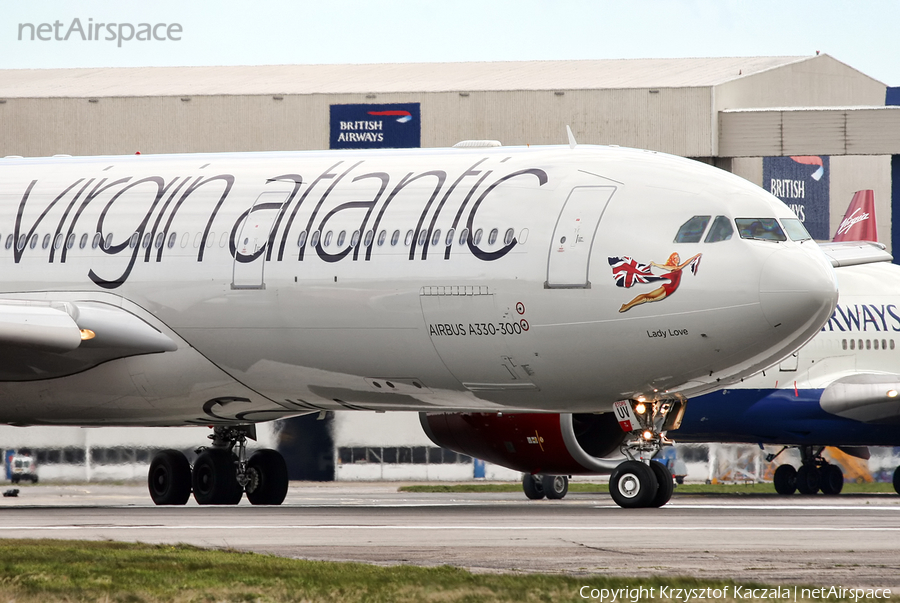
(763, 155, 831, 241)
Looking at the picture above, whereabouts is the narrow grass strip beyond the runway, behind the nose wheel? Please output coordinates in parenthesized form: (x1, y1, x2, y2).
(398, 482, 897, 496)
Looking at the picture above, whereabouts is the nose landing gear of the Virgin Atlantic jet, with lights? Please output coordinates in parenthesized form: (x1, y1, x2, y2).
(609, 397, 687, 509)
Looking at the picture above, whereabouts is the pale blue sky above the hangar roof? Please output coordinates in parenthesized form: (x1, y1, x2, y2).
(0, 0, 900, 86)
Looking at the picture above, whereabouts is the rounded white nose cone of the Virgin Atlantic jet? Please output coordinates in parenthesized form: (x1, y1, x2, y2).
(759, 248, 838, 332)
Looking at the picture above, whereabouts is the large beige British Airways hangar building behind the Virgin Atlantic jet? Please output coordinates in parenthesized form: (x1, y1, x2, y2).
(0, 55, 900, 478)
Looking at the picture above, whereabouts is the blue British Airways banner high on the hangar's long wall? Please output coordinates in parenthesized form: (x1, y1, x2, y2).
(330, 103, 422, 149)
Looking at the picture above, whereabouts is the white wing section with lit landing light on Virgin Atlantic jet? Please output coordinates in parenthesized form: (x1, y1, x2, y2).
(0, 299, 178, 381)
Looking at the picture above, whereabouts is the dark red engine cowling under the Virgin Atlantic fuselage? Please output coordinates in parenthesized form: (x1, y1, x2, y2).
(419, 412, 626, 475)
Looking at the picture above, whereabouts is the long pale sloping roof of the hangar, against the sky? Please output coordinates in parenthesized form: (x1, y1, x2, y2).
(0, 57, 815, 98)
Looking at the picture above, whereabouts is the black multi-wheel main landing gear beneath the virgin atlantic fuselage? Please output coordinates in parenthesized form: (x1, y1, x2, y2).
(147, 425, 288, 505)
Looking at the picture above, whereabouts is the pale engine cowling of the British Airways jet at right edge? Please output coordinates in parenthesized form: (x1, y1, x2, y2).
(819, 373, 900, 423)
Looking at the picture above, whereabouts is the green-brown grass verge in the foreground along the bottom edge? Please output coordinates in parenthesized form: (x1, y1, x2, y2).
(0, 539, 864, 603)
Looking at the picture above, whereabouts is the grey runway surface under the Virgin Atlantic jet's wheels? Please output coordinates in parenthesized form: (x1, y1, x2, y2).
(0, 483, 900, 592)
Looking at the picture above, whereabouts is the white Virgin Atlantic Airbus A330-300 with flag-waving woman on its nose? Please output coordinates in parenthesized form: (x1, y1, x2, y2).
(0, 141, 837, 504)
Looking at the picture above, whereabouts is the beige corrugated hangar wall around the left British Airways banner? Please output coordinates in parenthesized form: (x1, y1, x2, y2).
(0, 88, 714, 157)
